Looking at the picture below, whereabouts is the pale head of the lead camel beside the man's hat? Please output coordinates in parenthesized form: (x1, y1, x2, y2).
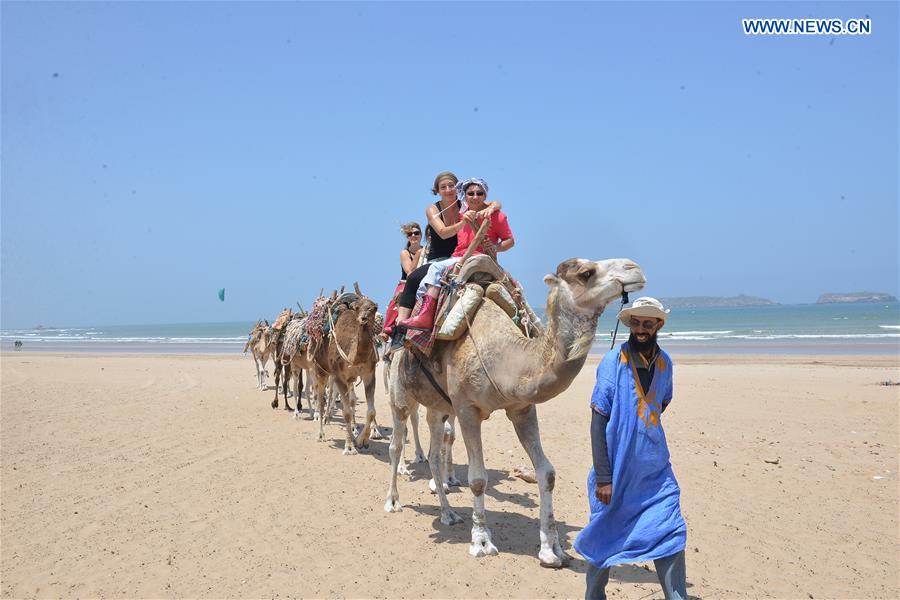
(544, 258, 647, 317)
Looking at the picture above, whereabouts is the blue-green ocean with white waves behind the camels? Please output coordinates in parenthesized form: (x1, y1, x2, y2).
(0, 303, 900, 355)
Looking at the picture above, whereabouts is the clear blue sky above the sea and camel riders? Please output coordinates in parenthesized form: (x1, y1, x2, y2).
(0, 2, 900, 328)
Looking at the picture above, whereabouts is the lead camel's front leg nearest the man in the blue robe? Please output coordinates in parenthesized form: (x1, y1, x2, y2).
(506, 406, 572, 568)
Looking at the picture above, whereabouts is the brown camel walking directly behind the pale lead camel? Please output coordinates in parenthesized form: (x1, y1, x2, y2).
(313, 284, 382, 454)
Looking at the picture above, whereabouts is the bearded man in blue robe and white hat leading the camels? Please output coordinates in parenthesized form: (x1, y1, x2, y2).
(575, 297, 687, 600)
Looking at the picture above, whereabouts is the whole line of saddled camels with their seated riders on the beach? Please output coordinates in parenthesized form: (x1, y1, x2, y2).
(245, 173, 645, 568)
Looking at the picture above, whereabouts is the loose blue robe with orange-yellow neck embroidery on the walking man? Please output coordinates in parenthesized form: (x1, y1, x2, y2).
(575, 342, 687, 569)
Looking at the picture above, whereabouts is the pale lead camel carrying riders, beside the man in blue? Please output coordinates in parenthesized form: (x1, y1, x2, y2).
(384, 258, 645, 568)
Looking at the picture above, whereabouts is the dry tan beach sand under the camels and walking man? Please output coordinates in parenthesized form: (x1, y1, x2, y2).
(0, 353, 900, 598)
